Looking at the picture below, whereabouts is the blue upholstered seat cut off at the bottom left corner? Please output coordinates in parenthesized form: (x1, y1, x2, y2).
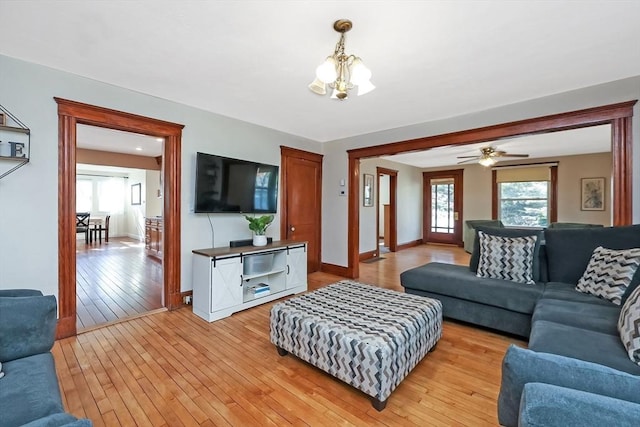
(0, 290, 93, 427)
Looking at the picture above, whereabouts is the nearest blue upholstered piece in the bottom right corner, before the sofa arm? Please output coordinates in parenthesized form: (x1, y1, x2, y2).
(518, 383, 640, 427)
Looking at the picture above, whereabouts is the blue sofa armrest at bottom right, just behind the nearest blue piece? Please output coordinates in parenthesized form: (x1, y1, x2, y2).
(498, 345, 640, 426)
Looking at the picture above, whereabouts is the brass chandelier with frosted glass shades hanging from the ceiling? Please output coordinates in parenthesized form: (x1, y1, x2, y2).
(309, 19, 376, 100)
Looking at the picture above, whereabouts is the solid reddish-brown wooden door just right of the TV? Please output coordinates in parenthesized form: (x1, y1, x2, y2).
(280, 147, 322, 273)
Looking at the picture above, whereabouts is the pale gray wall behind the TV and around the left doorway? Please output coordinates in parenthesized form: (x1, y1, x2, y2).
(0, 55, 322, 295)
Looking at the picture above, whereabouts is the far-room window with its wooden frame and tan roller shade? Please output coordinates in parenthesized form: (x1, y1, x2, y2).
(492, 164, 558, 227)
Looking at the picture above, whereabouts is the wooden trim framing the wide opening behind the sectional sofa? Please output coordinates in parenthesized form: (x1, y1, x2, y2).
(346, 100, 638, 278)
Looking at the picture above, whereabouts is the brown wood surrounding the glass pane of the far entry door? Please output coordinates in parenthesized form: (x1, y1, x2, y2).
(422, 169, 464, 246)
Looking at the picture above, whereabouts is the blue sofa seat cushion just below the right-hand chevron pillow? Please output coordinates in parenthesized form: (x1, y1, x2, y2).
(532, 298, 620, 335)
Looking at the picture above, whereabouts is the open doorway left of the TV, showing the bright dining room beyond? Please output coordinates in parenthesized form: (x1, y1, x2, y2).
(76, 124, 164, 332)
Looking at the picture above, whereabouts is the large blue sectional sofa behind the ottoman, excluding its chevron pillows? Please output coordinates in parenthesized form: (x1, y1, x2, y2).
(401, 225, 640, 426)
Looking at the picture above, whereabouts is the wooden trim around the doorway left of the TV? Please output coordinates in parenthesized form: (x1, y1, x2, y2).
(54, 98, 184, 339)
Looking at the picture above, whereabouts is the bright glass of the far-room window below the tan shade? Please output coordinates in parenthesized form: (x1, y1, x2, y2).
(498, 181, 549, 227)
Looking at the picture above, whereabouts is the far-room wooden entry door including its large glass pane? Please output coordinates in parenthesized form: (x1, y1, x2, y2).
(423, 169, 463, 246)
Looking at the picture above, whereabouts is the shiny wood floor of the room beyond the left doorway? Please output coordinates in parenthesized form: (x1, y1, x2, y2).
(76, 237, 162, 331)
